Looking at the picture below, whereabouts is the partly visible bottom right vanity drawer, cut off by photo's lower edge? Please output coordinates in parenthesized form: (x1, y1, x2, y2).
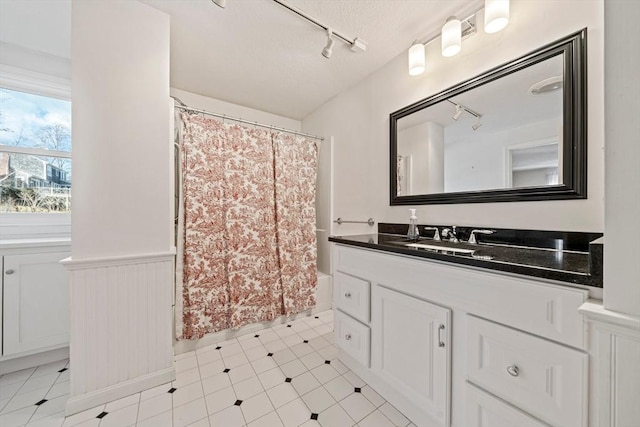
(465, 383, 549, 427)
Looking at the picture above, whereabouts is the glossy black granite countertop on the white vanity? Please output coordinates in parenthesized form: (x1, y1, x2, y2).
(329, 233, 602, 288)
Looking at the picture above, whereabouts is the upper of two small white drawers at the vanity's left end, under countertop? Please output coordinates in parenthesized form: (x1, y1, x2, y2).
(333, 271, 371, 323)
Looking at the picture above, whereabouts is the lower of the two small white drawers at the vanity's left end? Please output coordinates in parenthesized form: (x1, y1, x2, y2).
(334, 310, 371, 368)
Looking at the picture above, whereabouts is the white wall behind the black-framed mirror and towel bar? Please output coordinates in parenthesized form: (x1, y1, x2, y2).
(303, 0, 604, 234)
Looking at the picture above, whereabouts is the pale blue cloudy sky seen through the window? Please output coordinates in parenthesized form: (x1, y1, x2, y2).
(0, 88, 71, 147)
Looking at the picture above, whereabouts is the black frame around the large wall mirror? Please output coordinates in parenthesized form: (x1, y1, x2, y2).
(389, 28, 587, 206)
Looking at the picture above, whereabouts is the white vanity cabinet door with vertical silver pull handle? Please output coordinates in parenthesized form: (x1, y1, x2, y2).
(371, 286, 451, 426)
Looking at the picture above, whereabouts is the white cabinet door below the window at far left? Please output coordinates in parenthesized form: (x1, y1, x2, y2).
(2, 252, 70, 356)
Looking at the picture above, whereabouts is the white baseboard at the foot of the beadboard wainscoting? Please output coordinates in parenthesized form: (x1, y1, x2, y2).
(65, 367, 176, 417)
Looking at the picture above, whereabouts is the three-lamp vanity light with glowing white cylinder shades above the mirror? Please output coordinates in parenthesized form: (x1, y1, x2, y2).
(408, 0, 509, 76)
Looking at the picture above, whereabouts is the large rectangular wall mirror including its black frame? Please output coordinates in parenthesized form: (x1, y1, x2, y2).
(390, 29, 587, 205)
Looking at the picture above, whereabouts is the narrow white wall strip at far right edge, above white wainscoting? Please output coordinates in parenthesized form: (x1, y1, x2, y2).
(604, 0, 640, 316)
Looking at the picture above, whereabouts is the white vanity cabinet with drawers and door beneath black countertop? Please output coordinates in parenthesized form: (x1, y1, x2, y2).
(332, 244, 589, 427)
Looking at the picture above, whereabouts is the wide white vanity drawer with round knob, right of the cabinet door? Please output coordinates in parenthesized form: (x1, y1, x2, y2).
(467, 315, 588, 427)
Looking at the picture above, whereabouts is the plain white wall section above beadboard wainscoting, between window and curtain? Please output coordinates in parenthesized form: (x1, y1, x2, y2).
(72, 1, 173, 260)
